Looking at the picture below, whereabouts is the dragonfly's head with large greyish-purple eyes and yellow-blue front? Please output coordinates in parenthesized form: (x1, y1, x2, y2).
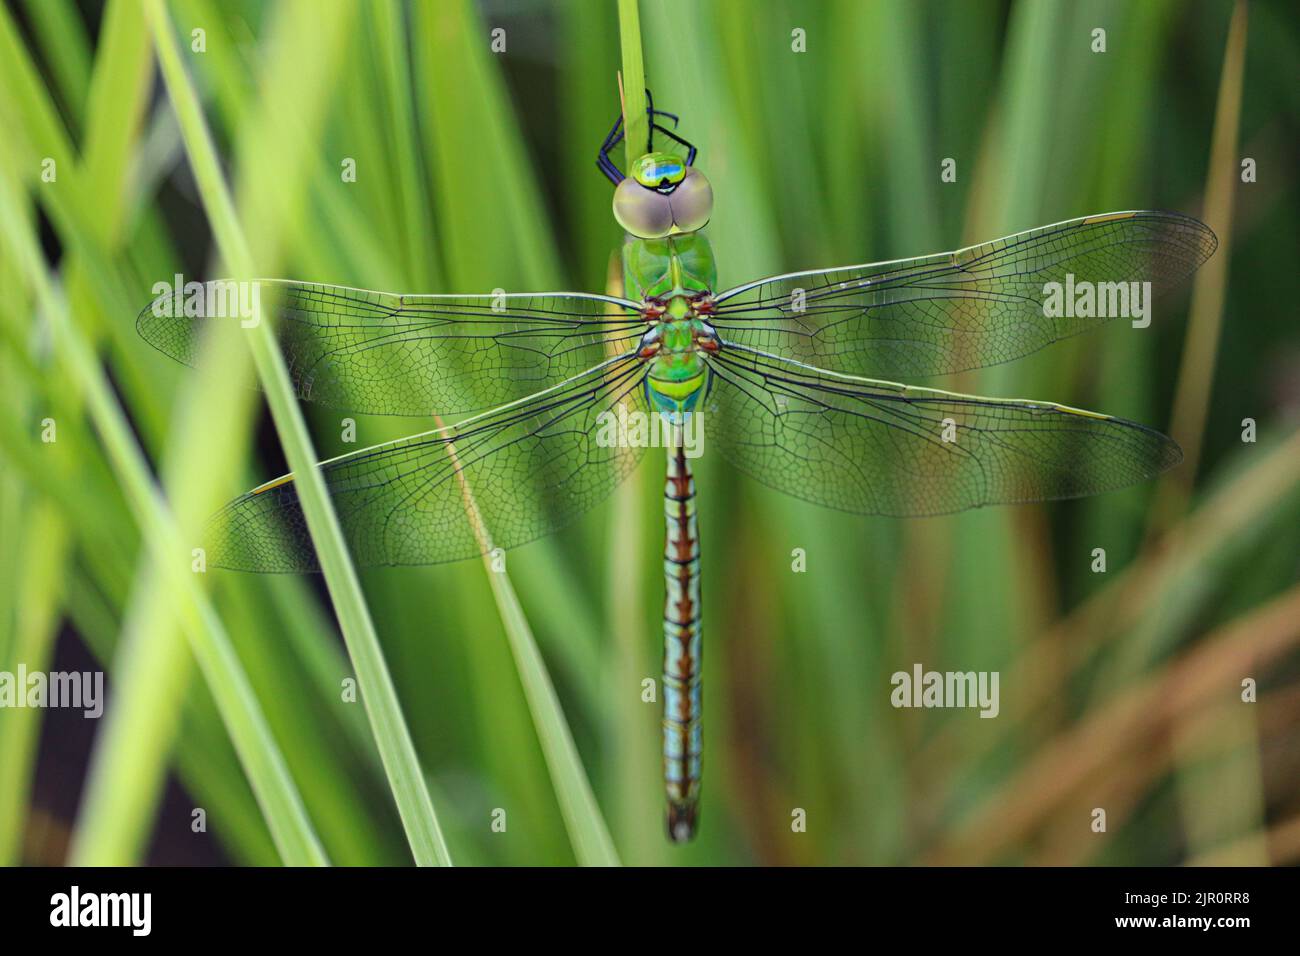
(614, 152, 714, 239)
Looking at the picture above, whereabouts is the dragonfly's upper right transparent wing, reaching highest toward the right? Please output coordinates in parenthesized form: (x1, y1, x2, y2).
(714, 212, 1218, 378)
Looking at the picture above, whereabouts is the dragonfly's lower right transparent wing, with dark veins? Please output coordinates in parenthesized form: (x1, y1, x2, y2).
(705, 347, 1182, 516)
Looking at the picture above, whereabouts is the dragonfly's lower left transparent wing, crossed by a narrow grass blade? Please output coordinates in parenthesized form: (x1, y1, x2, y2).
(207, 356, 646, 571)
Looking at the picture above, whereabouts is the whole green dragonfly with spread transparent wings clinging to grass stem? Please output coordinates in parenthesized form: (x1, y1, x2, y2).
(137, 91, 1217, 843)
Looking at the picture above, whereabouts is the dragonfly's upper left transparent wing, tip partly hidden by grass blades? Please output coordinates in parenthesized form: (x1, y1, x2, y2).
(137, 280, 645, 415)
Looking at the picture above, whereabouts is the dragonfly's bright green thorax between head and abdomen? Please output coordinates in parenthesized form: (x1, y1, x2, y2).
(623, 232, 718, 416)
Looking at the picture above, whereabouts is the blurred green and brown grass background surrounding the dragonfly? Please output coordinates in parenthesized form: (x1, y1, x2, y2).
(0, 0, 1300, 865)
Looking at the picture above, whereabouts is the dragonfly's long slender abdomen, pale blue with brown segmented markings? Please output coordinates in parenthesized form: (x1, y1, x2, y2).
(663, 429, 703, 843)
